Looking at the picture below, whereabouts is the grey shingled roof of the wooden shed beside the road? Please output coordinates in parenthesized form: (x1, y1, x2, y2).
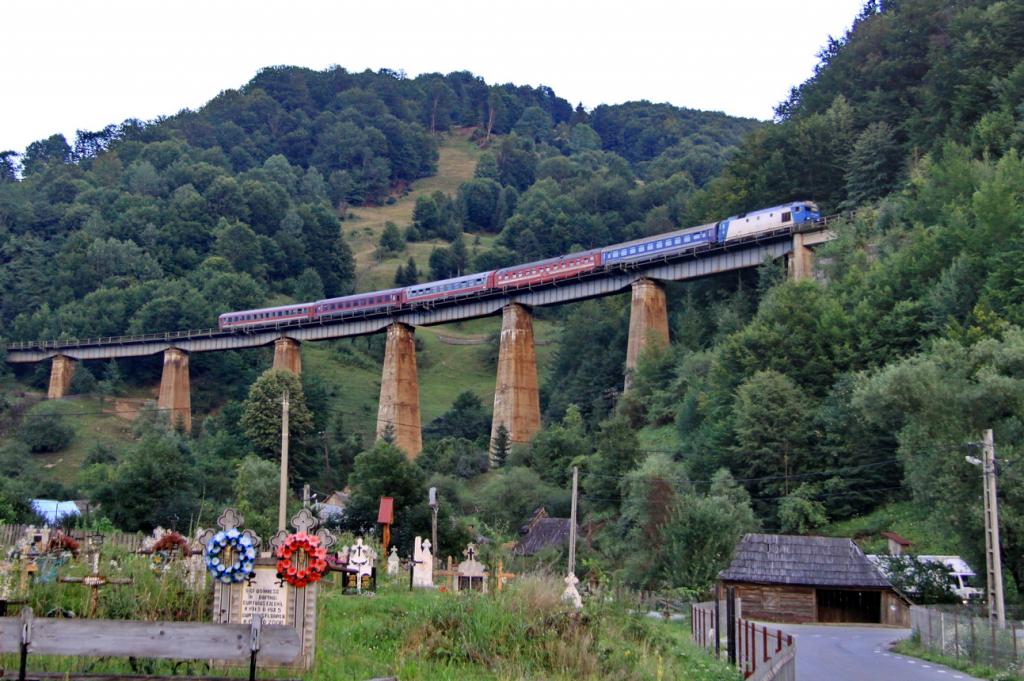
(719, 535, 893, 589)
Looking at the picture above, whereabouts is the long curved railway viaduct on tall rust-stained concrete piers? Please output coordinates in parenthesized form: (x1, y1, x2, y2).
(6, 227, 833, 458)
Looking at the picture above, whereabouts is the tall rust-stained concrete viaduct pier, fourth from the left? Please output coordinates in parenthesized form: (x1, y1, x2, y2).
(377, 323, 423, 459)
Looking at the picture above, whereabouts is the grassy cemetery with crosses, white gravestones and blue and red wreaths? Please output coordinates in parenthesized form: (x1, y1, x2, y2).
(0, 493, 732, 681)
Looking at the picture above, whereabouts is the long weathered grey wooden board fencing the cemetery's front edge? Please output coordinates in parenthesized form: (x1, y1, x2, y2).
(0, 618, 301, 665)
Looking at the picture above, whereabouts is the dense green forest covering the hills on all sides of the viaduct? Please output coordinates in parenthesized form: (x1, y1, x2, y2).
(0, 0, 1024, 593)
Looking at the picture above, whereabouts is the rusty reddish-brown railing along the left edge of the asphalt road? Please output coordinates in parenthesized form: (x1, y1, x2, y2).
(690, 599, 797, 681)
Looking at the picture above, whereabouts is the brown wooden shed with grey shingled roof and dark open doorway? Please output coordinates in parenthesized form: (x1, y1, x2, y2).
(719, 535, 910, 627)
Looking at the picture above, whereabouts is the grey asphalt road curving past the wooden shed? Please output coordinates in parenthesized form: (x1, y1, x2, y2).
(783, 625, 979, 681)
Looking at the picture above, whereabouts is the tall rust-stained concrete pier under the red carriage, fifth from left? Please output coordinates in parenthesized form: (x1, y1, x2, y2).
(490, 303, 541, 458)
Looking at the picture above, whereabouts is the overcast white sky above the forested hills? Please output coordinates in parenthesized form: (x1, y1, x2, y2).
(0, 0, 863, 152)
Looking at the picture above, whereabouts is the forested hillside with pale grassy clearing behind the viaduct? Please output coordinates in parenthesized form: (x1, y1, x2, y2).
(0, 67, 759, 548)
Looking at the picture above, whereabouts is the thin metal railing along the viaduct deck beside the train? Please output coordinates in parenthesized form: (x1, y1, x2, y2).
(6, 216, 836, 358)
